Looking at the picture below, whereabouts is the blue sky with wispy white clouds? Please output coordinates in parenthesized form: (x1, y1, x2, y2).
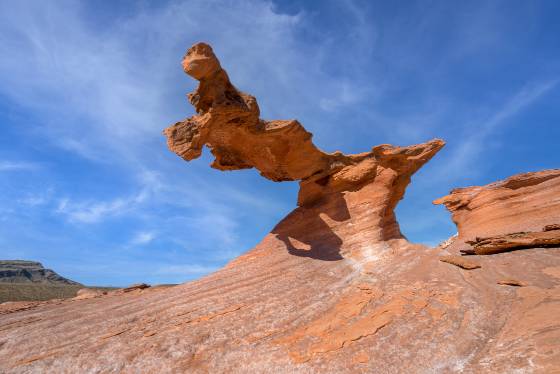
(0, 0, 560, 286)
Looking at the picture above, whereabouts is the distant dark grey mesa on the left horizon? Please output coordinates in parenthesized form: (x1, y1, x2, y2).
(0, 260, 79, 285)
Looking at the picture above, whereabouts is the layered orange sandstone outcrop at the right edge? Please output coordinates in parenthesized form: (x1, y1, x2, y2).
(434, 169, 560, 254)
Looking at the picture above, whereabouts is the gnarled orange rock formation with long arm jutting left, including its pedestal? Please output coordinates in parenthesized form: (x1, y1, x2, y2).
(164, 43, 444, 248)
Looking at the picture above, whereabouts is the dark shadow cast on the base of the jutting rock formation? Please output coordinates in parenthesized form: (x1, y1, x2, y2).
(272, 193, 350, 261)
